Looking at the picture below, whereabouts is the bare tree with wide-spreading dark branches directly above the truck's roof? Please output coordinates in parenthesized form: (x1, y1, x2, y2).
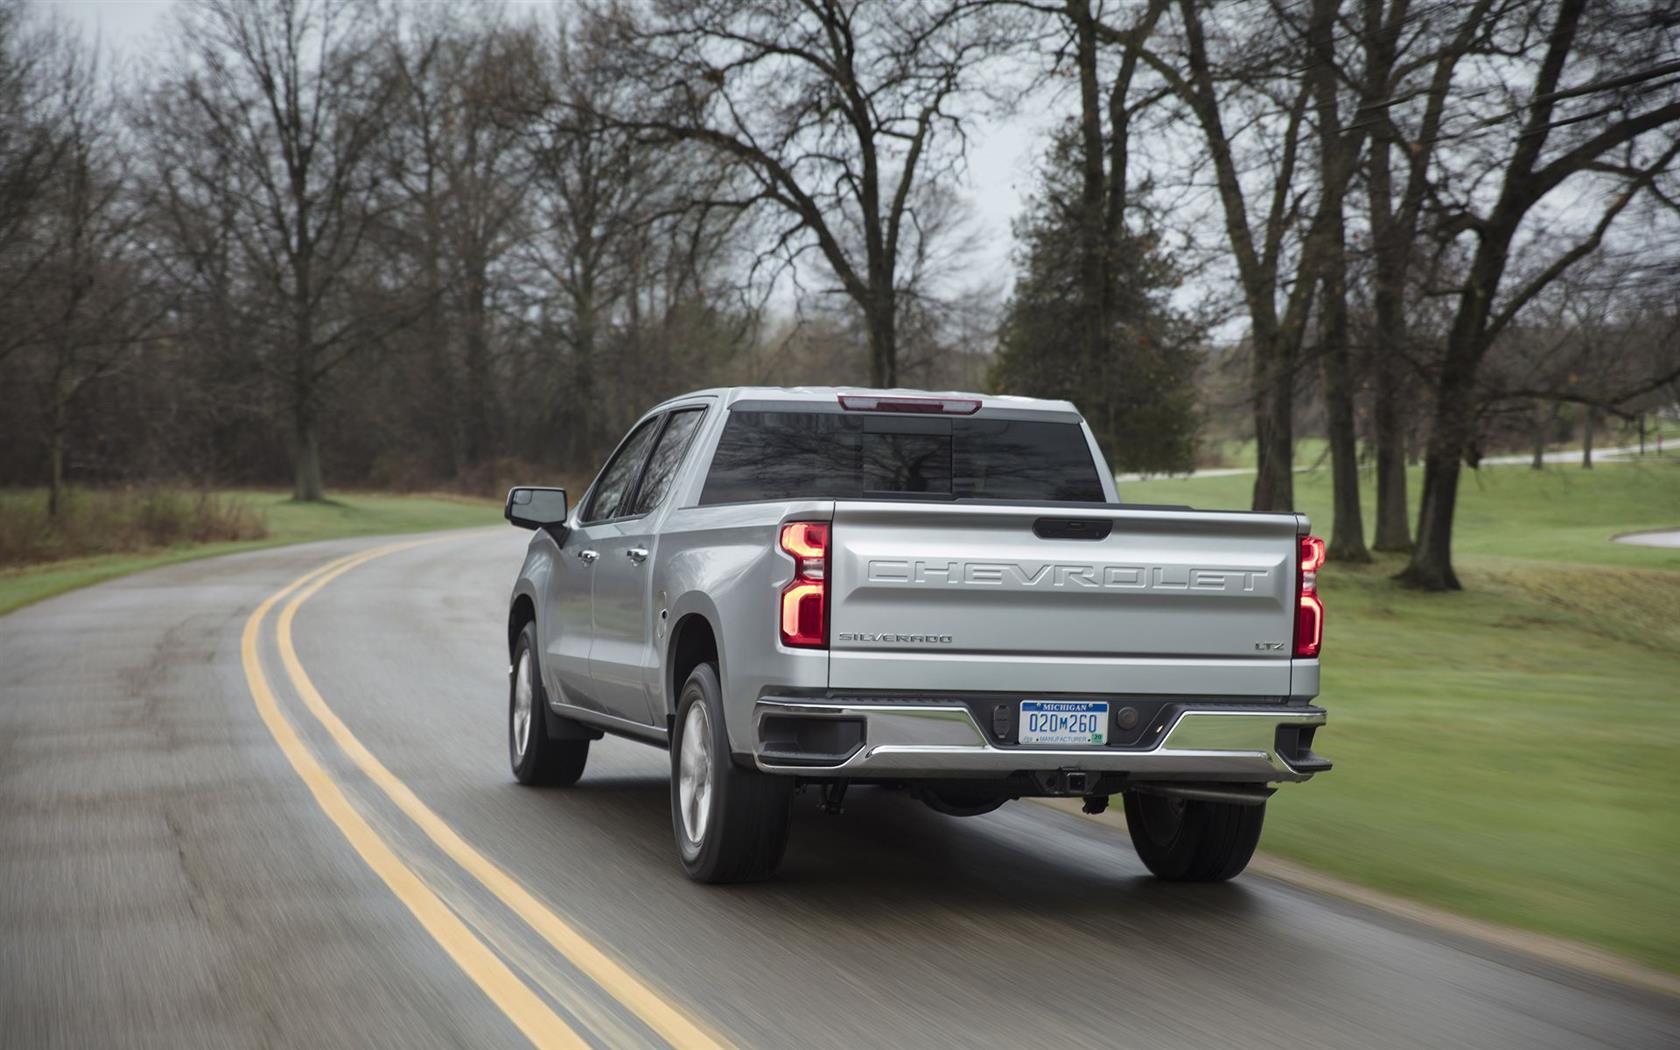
(584, 0, 1011, 386)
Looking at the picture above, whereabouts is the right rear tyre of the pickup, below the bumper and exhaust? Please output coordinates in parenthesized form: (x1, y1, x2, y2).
(1126, 791, 1265, 882)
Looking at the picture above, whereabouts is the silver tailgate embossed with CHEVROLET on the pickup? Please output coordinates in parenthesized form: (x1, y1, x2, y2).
(828, 501, 1300, 699)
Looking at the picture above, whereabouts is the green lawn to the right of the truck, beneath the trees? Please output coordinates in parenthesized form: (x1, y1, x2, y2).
(1121, 449, 1680, 971)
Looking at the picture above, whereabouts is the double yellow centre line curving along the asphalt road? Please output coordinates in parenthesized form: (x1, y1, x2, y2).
(240, 539, 727, 1050)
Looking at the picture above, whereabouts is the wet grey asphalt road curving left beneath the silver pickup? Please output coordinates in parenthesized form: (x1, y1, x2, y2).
(0, 531, 1680, 1050)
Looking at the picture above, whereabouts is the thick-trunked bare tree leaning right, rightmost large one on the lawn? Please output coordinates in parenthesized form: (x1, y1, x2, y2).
(1401, 0, 1680, 590)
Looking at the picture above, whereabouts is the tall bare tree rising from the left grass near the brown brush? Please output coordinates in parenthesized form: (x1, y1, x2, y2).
(155, 0, 391, 499)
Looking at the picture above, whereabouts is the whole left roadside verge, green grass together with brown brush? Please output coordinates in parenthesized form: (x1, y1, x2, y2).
(0, 489, 501, 613)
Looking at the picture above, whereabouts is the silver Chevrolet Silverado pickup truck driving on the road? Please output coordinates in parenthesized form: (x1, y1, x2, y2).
(506, 388, 1331, 882)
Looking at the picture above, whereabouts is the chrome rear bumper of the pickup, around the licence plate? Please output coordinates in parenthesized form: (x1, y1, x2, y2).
(753, 697, 1327, 783)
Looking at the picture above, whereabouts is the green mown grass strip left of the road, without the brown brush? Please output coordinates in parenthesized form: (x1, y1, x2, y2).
(0, 489, 501, 613)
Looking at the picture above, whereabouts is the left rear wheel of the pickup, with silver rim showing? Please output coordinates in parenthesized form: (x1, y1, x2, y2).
(670, 664, 793, 882)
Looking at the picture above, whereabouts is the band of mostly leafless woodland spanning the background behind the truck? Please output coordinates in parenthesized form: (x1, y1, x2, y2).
(0, 0, 1680, 588)
